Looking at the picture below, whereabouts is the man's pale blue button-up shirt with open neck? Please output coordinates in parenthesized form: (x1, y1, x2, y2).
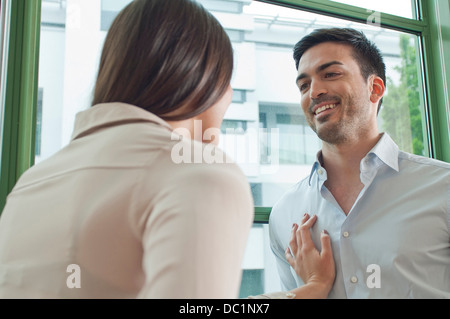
(269, 133, 450, 298)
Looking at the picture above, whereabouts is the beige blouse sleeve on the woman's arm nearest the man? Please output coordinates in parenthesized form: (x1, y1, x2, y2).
(139, 164, 253, 299)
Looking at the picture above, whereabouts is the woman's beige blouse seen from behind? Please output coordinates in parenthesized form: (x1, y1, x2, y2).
(0, 103, 253, 298)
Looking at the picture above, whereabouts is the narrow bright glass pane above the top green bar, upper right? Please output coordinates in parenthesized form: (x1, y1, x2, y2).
(332, 0, 417, 19)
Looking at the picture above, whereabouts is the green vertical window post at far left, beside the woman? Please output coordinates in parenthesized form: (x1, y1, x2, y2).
(0, 0, 41, 215)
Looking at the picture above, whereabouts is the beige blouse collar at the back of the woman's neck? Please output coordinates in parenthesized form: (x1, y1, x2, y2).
(72, 103, 172, 140)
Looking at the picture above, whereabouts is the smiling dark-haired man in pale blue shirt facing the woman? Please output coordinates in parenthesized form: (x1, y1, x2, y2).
(269, 29, 450, 298)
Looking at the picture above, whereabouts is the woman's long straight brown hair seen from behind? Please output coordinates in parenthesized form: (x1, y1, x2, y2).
(92, 0, 233, 121)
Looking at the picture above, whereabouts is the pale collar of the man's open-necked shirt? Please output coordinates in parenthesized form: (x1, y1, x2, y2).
(309, 133, 399, 186)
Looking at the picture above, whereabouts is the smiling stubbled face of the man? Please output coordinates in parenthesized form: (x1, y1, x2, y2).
(297, 42, 377, 144)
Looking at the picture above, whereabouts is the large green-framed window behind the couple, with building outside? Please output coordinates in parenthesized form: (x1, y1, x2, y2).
(0, 0, 450, 295)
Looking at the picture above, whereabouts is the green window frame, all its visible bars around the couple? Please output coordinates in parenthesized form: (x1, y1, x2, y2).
(0, 0, 450, 223)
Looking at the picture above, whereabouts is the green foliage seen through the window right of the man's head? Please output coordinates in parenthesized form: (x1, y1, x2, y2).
(380, 34, 424, 155)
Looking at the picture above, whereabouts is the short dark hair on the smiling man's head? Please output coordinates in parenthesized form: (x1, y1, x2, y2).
(294, 28, 386, 111)
